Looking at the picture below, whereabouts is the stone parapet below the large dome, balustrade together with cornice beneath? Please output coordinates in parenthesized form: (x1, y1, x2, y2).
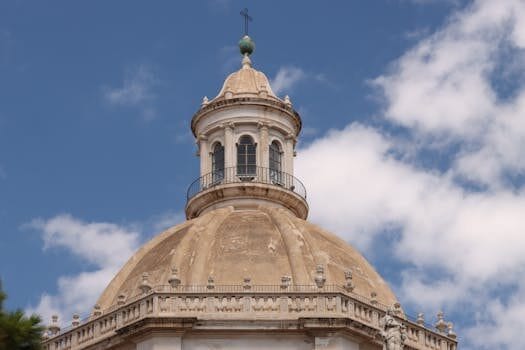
(43, 285, 457, 350)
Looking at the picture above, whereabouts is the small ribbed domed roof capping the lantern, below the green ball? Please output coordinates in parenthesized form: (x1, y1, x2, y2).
(213, 54, 282, 102)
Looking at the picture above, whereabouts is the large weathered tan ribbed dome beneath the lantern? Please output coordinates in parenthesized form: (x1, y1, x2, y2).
(98, 206, 397, 310)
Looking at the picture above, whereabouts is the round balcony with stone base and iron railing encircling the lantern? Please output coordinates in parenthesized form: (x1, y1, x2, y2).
(186, 165, 308, 219)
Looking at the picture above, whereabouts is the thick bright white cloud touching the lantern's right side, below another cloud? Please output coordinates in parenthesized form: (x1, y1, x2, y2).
(296, 124, 525, 348)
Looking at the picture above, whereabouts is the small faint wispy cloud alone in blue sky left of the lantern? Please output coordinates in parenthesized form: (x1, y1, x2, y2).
(103, 64, 158, 121)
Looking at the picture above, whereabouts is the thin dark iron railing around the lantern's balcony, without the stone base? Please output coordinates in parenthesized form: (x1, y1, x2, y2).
(186, 165, 306, 200)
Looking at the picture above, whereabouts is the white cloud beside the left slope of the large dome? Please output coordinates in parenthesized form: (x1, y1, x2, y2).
(25, 215, 139, 322)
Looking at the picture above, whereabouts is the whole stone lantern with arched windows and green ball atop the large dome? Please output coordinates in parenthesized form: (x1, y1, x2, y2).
(186, 35, 308, 219)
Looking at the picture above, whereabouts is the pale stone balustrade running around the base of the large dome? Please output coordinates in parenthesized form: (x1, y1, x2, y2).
(43, 285, 457, 350)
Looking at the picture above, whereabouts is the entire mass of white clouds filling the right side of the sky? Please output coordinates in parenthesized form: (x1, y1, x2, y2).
(296, 0, 525, 349)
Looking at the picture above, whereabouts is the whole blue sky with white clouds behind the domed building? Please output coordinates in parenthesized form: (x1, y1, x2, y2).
(0, 0, 525, 349)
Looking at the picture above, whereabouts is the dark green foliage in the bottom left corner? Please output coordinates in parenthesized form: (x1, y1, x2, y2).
(0, 283, 44, 350)
